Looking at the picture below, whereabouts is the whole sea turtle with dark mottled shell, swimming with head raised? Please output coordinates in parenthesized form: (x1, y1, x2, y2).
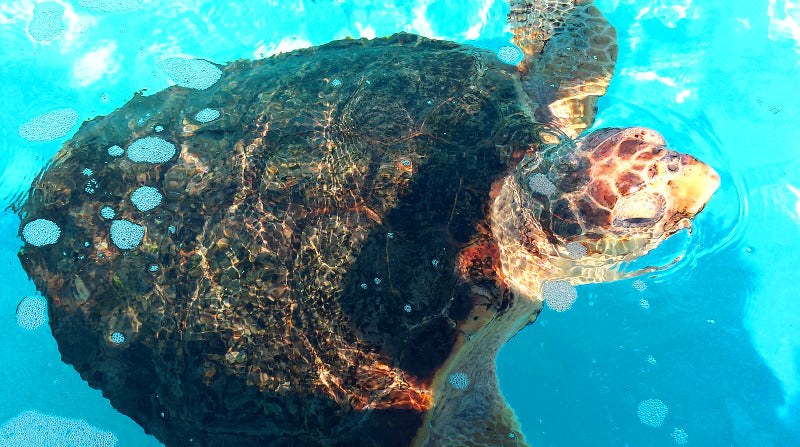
(19, 0, 719, 446)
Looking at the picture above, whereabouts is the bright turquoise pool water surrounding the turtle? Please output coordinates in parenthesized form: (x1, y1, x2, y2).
(0, 0, 800, 446)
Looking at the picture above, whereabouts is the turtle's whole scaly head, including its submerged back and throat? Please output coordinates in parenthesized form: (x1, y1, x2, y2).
(496, 127, 720, 283)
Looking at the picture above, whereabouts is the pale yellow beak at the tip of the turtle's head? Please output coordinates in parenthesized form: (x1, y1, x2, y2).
(670, 154, 720, 218)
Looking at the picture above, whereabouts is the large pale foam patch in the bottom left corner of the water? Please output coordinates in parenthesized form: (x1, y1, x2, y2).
(0, 410, 117, 447)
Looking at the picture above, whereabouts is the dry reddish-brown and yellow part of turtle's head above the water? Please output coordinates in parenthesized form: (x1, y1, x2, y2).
(572, 127, 720, 248)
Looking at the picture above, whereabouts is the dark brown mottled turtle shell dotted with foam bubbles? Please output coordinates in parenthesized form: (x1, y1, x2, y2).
(19, 34, 538, 446)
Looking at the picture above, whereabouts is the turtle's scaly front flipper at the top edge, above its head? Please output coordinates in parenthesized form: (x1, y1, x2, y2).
(508, 0, 617, 138)
